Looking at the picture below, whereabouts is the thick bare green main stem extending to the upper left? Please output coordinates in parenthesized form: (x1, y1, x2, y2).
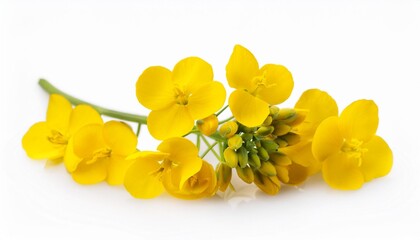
(38, 79, 147, 125)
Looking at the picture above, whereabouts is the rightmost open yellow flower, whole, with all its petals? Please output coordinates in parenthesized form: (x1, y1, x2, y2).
(312, 100, 393, 190)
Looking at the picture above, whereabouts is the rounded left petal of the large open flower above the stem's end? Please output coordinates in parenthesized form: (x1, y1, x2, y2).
(136, 66, 175, 110)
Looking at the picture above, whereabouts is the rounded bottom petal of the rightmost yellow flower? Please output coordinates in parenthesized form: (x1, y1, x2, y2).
(322, 152, 364, 190)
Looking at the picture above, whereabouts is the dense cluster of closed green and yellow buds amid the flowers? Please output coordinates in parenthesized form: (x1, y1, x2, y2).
(220, 106, 305, 183)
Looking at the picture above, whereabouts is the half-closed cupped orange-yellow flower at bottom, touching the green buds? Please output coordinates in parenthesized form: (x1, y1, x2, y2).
(163, 160, 217, 200)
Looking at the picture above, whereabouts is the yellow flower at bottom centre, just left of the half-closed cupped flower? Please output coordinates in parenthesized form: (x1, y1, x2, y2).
(124, 137, 203, 199)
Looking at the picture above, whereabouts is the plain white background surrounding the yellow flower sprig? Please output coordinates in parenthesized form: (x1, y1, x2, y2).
(0, 0, 420, 239)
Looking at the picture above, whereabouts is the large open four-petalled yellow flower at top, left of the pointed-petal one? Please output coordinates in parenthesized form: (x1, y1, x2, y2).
(136, 57, 226, 140)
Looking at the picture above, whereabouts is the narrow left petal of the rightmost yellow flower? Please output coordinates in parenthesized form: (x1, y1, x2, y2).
(312, 117, 343, 162)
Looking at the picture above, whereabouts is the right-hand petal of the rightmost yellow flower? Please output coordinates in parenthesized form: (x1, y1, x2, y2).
(360, 136, 393, 182)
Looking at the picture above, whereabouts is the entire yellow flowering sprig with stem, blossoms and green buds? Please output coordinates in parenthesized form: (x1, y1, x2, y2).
(22, 45, 393, 199)
